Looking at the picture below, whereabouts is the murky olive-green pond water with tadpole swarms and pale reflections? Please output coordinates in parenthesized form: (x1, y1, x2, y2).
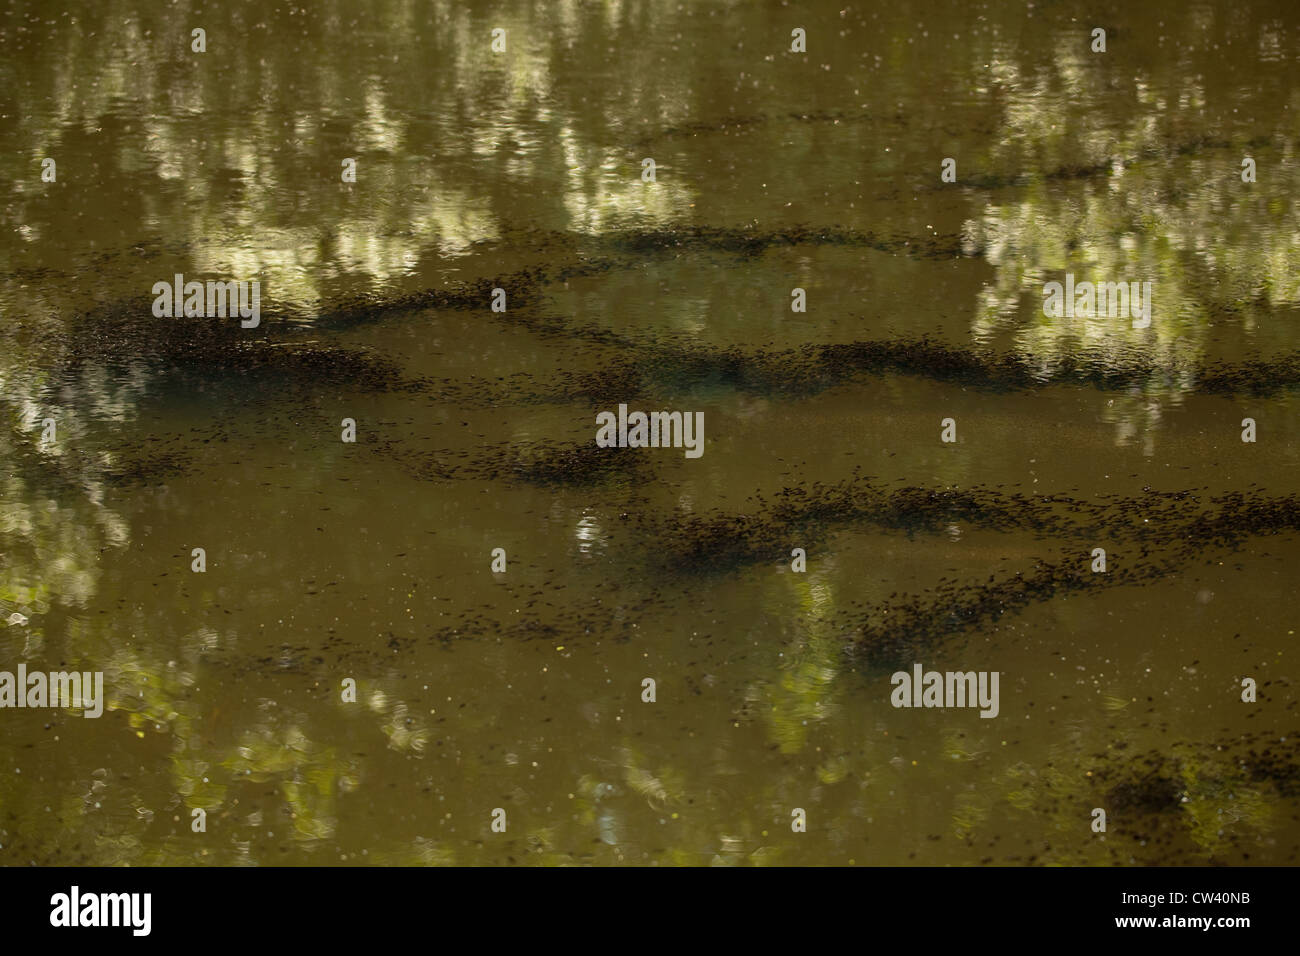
(0, 0, 1300, 865)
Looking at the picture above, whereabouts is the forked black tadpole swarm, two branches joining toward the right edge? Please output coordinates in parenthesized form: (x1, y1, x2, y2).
(611, 477, 1300, 660)
